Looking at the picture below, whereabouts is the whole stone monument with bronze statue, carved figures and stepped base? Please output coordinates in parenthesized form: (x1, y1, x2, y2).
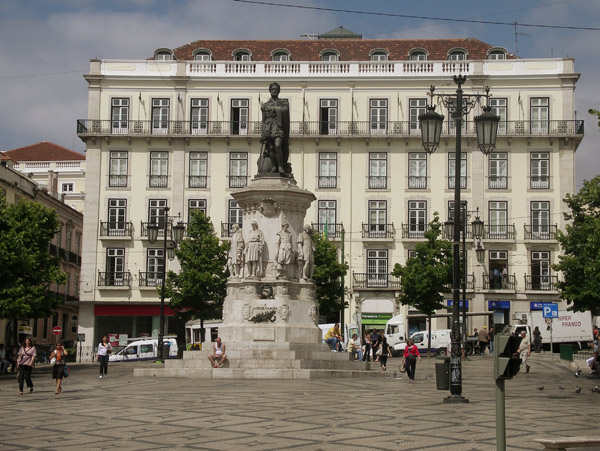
(134, 83, 394, 379)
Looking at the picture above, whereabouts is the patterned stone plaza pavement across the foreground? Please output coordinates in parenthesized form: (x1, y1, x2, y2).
(0, 353, 600, 451)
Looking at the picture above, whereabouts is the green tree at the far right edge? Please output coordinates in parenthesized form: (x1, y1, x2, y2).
(552, 175, 600, 314)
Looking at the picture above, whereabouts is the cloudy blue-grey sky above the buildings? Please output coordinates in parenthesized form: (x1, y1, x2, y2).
(0, 0, 600, 189)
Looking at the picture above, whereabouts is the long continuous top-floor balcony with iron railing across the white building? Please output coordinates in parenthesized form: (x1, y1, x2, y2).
(77, 119, 584, 140)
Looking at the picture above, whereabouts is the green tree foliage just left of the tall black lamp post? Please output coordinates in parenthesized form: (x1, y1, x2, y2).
(392, 212, 452, 315)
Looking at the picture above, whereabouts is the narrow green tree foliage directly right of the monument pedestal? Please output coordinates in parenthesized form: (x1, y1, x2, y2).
(312, 232, 348, 322)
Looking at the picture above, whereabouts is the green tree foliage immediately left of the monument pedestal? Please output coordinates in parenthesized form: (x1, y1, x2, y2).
(165, 211, 229, 320)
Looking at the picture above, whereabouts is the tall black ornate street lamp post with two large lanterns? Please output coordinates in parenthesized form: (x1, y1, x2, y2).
(419, 75, 500, 403)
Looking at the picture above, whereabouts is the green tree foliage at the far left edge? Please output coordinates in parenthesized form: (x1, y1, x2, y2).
(0, 196, 67, 319)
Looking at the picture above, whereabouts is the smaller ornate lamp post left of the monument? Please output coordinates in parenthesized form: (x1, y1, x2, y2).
(147, 207, 185, 363)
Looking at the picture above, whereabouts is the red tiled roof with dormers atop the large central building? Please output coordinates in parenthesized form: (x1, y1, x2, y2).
(166, 38, 518, 61)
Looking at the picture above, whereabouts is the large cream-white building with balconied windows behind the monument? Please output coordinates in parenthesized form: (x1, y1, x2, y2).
(78, 33, 583, 341)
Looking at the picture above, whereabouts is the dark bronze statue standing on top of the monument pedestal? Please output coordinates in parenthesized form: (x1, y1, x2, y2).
(258, 82, 292, 177)
